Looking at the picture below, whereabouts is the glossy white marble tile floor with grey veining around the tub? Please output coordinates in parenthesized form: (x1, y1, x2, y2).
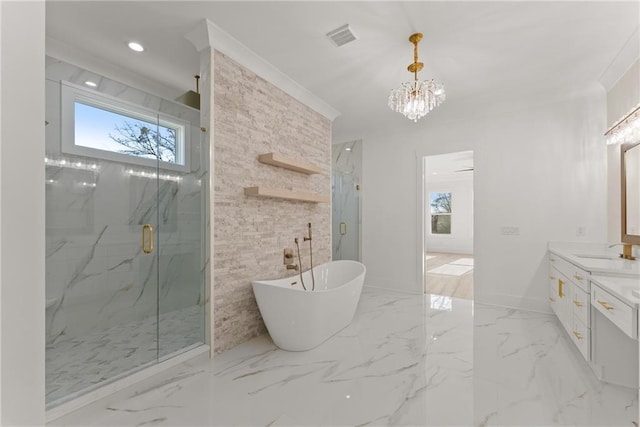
(52, 288, 638, 426)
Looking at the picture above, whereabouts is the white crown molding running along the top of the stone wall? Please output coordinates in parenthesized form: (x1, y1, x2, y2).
(185, 19, 340, 121)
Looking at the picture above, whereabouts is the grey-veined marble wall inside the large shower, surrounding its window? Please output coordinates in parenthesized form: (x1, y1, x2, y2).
(46, 57, 208, 354)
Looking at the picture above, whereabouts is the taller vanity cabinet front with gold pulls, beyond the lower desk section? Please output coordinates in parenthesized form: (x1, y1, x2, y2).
(549, 253, 591, 361)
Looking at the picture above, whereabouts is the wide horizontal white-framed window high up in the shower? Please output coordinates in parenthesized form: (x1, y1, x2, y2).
(62, 83, 190, 171)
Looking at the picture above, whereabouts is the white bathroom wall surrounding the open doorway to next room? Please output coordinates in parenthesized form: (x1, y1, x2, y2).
(362, 85, 607, 311)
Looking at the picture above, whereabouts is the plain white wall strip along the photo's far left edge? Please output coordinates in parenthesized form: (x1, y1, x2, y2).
(0, 1, 45, 425)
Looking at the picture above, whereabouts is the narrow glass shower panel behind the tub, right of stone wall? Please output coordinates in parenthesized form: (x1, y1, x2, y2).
(332, 141, 362, 261)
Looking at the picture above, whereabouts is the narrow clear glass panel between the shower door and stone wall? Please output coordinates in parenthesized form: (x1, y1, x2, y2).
(158, 103, 208, 359)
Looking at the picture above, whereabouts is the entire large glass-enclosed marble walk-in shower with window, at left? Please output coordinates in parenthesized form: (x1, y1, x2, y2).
(44, 57, 209, 408)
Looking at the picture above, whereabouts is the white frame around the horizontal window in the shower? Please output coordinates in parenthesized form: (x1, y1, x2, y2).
(60, 81, 191, 172)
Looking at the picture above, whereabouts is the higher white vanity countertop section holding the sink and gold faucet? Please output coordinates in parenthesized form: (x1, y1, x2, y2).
(549, 242, 640, 283)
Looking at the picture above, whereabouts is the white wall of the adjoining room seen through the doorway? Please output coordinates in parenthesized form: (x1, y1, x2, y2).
(425, 176, 473, 254)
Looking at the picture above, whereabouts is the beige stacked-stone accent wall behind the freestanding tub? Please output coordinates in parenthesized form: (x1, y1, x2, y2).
(213, 51, 331, 352)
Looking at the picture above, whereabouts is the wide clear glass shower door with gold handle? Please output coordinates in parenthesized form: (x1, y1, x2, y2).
(45, 77, 158, 407)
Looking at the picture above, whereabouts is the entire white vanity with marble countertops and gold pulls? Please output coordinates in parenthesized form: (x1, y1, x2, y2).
(548, 247, 640, 387)
